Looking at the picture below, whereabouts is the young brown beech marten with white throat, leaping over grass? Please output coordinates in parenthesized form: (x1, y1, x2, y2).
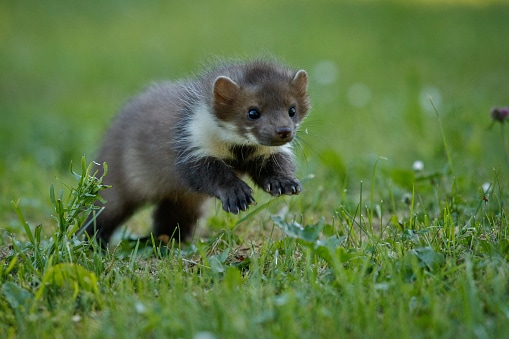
(86, 60, 310, 245)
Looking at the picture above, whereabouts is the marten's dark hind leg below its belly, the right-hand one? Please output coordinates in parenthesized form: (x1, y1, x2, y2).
(153, 198, 203, 241)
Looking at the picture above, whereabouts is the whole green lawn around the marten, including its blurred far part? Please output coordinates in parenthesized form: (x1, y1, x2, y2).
(0, 0, 509, 338)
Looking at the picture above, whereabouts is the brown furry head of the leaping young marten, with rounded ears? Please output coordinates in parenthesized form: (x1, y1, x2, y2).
(213, 62, 310, 146)
